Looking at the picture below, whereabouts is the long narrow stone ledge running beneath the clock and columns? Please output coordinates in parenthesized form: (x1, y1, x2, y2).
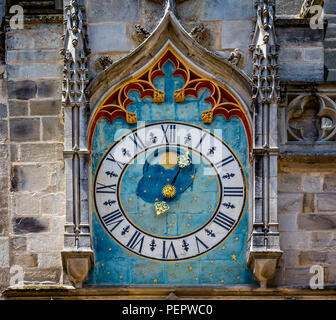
(3, 286, 336, 300)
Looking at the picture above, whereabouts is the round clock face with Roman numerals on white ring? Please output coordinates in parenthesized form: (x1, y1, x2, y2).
(93, 121, 247, 261)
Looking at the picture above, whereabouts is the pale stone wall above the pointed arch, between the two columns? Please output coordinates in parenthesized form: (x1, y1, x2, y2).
(86, 0, 254, 78)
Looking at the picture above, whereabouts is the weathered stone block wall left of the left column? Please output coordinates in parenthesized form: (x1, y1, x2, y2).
(0, 14, 65, 286)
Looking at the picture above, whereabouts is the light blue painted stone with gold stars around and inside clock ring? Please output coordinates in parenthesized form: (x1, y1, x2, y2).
(86, 62, 255, 286)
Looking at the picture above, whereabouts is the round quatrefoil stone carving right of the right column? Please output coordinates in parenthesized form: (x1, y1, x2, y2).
(287, 94, 336, 144)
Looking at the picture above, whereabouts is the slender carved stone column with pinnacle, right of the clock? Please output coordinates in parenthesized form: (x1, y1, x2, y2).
(247, 0, 282, 287)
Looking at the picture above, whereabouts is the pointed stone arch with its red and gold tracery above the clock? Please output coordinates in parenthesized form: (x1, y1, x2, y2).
(87, 10, 253, 155)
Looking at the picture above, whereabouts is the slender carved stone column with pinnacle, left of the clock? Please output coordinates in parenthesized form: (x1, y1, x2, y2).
(61, 0, 94, 287)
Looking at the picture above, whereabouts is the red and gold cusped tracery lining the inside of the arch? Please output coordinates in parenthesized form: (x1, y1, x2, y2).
(89, 49, 252, 155)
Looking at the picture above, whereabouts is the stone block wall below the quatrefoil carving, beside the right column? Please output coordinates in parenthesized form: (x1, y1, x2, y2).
(272, 157, 336, 287)
